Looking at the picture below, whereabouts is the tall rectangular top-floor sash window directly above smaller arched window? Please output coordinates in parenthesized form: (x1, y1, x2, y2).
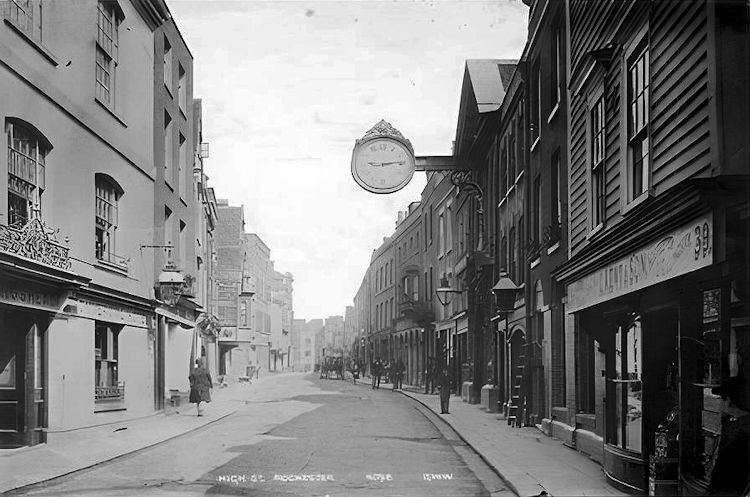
(96, 0, 122, 107)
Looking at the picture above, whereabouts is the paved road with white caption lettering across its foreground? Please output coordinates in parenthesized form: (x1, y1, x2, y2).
(14, 375, 512, 497)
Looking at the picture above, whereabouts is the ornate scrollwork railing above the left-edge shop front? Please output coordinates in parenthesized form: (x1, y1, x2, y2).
(0, 219, 70, 270)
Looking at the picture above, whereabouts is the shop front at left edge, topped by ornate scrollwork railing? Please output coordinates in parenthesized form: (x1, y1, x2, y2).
(0, 219, 88, 448)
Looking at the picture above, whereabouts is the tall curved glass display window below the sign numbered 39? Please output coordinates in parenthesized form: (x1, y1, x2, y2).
(608, 315, 643, 452)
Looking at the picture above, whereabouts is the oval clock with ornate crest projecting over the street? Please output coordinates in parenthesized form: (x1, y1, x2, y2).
(352, 120, 415, 193)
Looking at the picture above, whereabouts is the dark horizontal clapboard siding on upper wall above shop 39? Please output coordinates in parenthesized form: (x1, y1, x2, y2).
(569, 0, 712, 254)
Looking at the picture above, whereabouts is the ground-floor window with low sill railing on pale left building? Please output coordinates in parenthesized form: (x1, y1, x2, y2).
(94, 321, 125, 402)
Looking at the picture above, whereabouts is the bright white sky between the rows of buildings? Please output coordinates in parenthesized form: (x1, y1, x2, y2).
(169, 0, 528, 319)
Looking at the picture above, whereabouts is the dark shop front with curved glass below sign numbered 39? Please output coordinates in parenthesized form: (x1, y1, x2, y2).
(566, 204, 750, 495)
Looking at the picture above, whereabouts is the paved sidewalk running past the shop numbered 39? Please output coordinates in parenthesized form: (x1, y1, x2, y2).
(368, 376, 628, 497)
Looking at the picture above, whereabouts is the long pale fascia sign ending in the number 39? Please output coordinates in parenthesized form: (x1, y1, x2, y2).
(568, 213, 713, 312)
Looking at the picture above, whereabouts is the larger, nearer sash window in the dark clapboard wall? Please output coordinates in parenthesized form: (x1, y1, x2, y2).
(627, 42, 651, 201)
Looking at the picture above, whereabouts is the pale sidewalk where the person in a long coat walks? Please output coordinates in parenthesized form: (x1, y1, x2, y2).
(0, 376, 264, 494)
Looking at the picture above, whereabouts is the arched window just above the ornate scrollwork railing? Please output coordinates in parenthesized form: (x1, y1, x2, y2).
(5, 121, 51, 226)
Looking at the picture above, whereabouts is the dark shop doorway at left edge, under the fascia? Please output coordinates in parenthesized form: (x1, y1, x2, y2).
(0, 310, 49, 448)
